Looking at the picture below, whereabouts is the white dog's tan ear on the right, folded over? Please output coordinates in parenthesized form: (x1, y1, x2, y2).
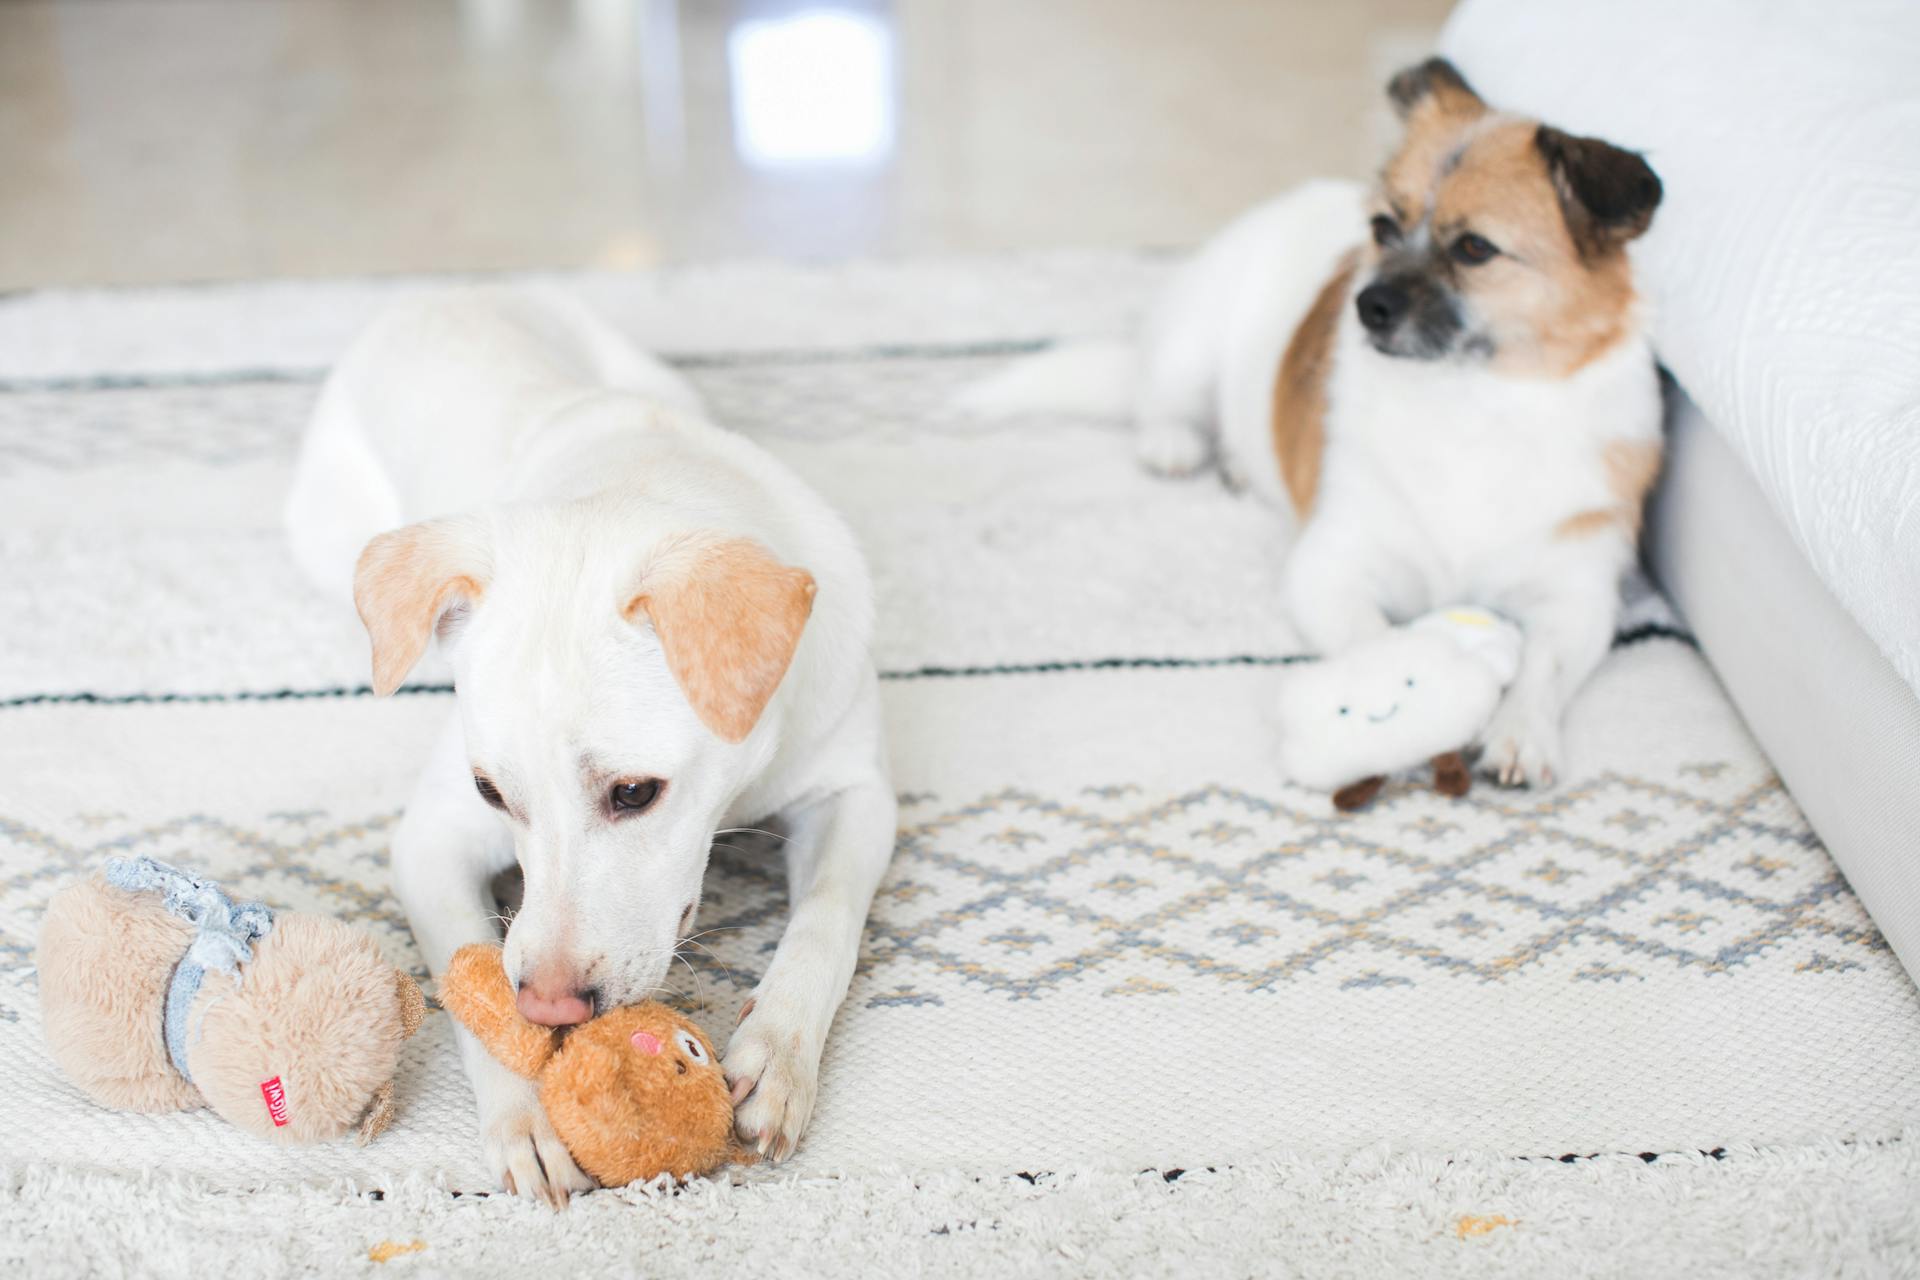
(620, 537, 814, 743)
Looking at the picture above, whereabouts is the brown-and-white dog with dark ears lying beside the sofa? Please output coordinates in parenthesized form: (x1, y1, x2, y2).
(966, 58, 1661, 785)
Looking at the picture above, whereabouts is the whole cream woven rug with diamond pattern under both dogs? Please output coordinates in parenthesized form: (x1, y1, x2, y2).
(0, 255, 1920, 1274)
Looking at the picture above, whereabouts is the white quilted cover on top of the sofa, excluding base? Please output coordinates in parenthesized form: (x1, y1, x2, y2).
(1442, 0, 1920, 691)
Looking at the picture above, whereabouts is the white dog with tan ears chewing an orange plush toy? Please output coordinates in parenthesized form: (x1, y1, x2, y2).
(288, 290, 895, 1203)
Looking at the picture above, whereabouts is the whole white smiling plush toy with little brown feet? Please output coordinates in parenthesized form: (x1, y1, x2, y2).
(1279, 608, 1521, 810)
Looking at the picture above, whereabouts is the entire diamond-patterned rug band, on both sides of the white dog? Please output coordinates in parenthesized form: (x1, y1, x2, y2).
(0, 773, 1885, 1036)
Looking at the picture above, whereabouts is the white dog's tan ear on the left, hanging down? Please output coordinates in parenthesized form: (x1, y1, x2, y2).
(353, 516, 492, 695)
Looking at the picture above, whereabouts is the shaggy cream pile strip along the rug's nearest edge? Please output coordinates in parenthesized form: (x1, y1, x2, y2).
(0, 1130, 1920, 1280)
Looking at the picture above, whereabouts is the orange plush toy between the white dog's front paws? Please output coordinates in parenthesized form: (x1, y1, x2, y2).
(440, 942, 745, 1186)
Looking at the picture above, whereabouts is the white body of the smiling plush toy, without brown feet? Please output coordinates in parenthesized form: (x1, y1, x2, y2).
(1281, 628, 1500, 789)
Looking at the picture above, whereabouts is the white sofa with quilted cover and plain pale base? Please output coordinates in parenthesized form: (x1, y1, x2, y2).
(1440, 0, 1920, 975)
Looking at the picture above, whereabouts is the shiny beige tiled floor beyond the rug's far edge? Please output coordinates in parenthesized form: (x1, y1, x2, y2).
(0, 0, 1448, 288)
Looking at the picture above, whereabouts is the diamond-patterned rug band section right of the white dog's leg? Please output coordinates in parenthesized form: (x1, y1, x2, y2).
(862, 773, 1885, 1000)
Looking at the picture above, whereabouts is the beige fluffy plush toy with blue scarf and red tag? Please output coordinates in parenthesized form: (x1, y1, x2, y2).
(35, 858, 426, 1144)
